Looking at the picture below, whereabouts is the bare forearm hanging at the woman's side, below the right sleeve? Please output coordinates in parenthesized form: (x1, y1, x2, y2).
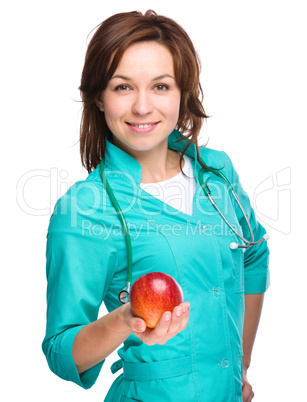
(243, 293, 264, 369)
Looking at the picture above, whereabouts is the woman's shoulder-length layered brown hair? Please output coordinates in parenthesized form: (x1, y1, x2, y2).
(79, 10, 209, 173)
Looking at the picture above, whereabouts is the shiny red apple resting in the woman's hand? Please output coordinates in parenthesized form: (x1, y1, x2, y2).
(130, 272, 183, 328)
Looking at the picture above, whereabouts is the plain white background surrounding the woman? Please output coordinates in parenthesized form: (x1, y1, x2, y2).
(0, 0, 307, 402)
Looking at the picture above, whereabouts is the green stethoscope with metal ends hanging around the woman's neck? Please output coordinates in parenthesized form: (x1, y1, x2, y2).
(100, 158, 269, 304)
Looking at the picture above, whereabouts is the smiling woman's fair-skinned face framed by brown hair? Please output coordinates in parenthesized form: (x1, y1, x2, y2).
(97, 42, 180, 156)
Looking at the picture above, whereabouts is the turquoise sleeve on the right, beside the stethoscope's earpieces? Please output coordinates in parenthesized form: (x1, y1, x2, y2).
(224, 152, 270, 294)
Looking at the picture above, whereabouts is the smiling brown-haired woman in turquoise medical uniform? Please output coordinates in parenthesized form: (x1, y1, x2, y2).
(43, 11, 269, 402)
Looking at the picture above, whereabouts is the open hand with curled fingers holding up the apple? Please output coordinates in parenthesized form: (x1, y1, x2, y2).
(124, 302, 190, 346)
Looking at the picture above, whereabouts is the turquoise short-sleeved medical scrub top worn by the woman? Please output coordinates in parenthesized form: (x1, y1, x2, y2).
(43, 130, 269, 402)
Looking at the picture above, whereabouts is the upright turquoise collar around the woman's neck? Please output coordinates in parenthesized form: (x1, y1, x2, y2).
(104, 130, 200, 185)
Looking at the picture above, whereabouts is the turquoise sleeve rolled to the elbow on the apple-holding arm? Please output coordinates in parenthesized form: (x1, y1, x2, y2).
(42, 181, 117, 389)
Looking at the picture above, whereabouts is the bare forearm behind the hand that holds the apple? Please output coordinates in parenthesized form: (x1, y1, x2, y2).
(72, 305, 131, 373)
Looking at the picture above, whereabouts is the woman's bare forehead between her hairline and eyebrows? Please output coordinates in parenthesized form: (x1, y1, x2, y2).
(114, 42, 174, 75)
